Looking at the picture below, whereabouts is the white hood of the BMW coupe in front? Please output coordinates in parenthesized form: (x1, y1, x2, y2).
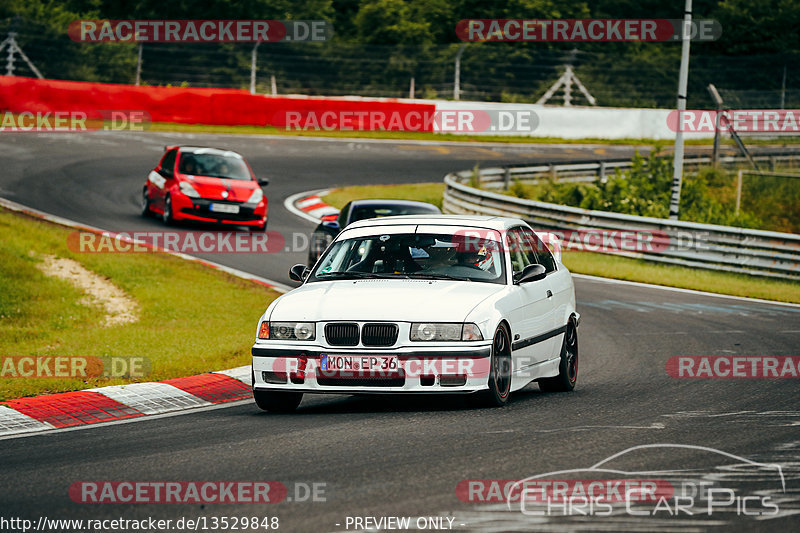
(270, 279, 503, 322)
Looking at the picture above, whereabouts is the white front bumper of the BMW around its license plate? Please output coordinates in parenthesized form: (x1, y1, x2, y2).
(252, 341, 491, 394)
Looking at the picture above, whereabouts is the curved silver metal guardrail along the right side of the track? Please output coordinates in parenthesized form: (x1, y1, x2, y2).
(443, 152, 800, 280)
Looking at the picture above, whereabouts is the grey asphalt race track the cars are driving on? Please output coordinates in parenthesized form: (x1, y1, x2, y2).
(0, 133, 800, 532)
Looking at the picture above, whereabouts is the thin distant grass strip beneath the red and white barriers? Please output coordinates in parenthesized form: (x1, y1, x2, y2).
(146, 122, 800, 146)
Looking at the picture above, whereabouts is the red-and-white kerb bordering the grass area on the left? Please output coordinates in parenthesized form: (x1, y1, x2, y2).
(0, 198, 289, 438)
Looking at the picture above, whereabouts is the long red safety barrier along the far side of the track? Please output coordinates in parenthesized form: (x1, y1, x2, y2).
(0, 76, 436, 131)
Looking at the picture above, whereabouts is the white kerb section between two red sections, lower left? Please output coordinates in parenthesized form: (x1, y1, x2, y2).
(87, 382, 211, 415)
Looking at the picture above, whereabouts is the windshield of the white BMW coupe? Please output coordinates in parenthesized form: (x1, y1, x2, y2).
(308, 233, 505, 284)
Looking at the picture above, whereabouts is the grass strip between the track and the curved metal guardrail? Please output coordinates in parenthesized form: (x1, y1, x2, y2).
(323, 183, 800, 303)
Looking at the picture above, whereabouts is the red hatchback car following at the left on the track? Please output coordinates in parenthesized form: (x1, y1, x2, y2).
(142, 146, 269, 231)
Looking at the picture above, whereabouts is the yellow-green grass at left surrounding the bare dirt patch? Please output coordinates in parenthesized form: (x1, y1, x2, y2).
(0, 209, 278, 400)
